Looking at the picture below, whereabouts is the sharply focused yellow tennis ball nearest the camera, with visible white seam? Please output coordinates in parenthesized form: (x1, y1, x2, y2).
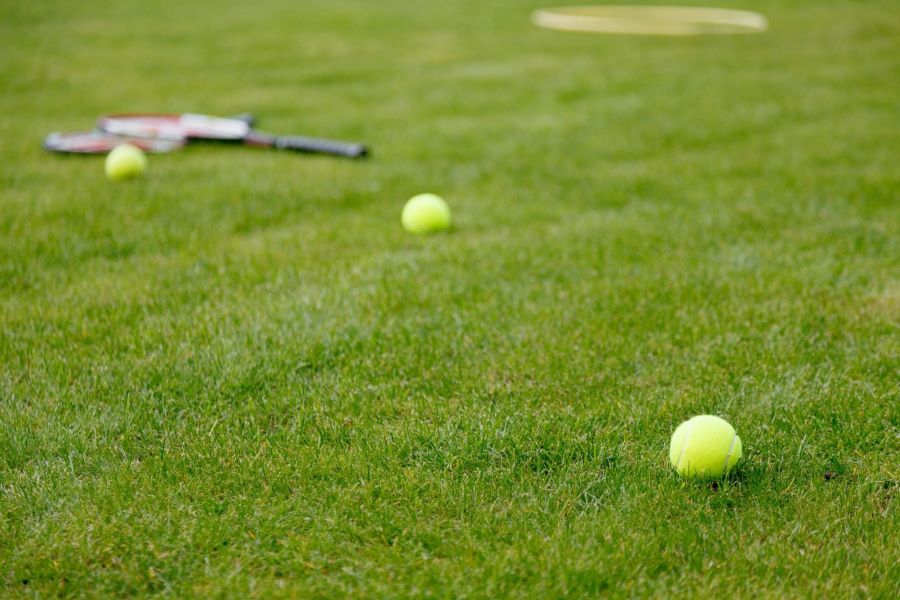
(669, 415, 743, 479)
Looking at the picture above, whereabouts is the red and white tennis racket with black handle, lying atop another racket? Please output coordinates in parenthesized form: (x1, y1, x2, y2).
(97, 113, 368, 158)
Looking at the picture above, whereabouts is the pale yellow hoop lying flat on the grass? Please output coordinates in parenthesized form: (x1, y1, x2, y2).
(531, 6, 769, 35)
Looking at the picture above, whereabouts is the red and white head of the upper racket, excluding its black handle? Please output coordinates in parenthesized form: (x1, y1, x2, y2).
(97, 113, 250, 141)
